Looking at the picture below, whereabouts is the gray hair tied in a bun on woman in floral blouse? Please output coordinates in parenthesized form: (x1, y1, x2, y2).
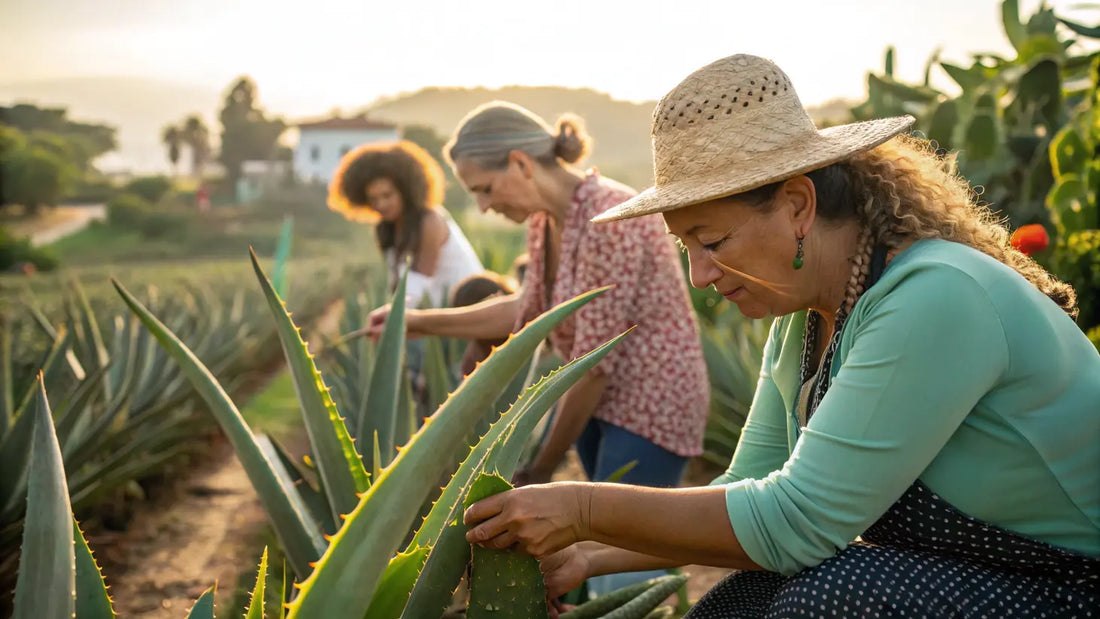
(443, 101, 591, 169)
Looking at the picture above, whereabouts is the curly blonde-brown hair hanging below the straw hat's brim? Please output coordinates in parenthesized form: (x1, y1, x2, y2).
(838, 136, 1077, 318)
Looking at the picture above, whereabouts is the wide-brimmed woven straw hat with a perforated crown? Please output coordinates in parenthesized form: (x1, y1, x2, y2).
(592, 54, 914, 223)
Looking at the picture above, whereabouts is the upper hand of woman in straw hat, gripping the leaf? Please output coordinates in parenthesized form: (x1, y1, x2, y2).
(463, 482, 592, 560)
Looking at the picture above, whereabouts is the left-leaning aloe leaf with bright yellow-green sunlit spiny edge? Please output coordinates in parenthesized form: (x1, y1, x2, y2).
(249, 247, 369, 523)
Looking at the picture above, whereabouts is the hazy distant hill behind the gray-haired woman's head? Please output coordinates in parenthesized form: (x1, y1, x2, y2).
(365, 86, 851, 190)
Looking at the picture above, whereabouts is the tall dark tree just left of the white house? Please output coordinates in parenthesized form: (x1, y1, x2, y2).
(218, 77, 286, 186)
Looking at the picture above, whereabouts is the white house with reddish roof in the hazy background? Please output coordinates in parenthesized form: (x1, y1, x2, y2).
(294, 114, 400, 183)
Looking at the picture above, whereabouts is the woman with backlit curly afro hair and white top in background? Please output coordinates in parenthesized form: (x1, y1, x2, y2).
(328, 140, 482, 307)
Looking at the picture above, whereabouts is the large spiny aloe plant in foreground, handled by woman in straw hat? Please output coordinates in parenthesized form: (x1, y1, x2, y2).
(108, 247, 638, 618)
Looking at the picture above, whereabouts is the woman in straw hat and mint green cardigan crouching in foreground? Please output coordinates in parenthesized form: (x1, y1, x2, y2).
(465, 55, 1100, 618)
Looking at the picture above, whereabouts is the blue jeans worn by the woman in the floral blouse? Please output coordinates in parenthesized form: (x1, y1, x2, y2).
(576, 419, 688, 596)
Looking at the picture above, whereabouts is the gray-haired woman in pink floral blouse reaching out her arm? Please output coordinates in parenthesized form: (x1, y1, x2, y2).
(366, 102, 708, 499)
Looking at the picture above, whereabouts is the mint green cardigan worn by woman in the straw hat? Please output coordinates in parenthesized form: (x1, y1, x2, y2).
(714, 240, 1100, 574)
